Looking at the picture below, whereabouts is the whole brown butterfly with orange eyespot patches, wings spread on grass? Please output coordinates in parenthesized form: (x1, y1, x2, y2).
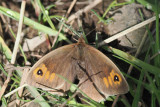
(27, 38, 129, 102)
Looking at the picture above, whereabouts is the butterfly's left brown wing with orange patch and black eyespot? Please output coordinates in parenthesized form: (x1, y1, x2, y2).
(27, 44, 75, 95)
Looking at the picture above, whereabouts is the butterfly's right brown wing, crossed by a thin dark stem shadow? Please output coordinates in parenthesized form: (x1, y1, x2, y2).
(80, 45, 129, 101)
